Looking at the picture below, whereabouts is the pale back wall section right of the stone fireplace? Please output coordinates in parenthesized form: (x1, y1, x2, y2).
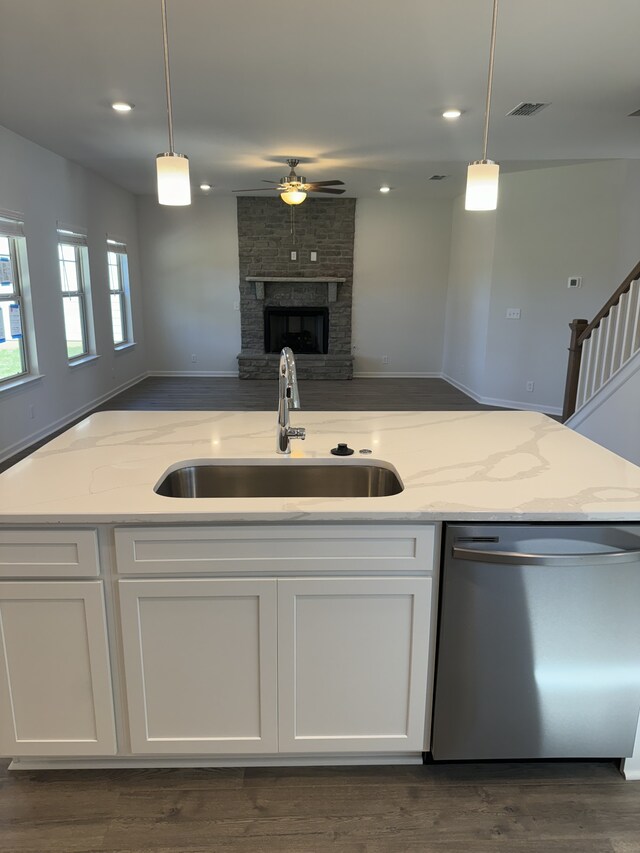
(352, 197, 451, 376)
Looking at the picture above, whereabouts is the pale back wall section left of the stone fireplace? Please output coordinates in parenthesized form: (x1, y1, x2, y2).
(138, 196, 240, 376)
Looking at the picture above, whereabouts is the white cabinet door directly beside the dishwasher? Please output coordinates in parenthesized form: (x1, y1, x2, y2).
(278, 578, 431, 752)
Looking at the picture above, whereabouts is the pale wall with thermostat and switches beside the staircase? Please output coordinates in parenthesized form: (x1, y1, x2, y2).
(445, 161, 638, 412)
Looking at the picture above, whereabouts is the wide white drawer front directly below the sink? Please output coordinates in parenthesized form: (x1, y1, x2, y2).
(115, 525, 437, 575)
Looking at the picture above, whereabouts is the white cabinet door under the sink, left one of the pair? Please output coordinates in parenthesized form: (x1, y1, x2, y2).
(119, 579, 278, 754)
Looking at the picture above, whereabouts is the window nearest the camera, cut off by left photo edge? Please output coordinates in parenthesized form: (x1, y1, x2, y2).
(0, 212, 35, 387)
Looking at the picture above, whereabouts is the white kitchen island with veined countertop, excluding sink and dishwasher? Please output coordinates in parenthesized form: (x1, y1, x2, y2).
(0, 411, 640, 775)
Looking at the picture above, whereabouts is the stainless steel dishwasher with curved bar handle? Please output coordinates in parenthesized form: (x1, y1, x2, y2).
(432, 524, 640, 760)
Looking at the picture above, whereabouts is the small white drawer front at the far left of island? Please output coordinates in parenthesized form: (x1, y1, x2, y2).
(0, 530, 100, 578)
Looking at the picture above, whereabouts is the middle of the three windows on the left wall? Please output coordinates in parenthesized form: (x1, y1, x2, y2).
(58, 228, 93, 362)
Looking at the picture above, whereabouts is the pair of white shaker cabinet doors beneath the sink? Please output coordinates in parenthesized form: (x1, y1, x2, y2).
(119, 577, 431, 755)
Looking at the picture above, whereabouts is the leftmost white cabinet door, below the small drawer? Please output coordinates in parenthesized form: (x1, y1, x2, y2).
(0, 581, 116, 756)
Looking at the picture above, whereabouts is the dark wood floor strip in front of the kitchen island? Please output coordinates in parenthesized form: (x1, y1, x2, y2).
(0, 762, 640, 853)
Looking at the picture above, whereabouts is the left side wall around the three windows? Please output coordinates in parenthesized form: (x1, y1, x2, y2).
(0, 123, 146, 458)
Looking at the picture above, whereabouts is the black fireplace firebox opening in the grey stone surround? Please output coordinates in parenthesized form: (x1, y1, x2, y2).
(264, 307, 329, 354)
